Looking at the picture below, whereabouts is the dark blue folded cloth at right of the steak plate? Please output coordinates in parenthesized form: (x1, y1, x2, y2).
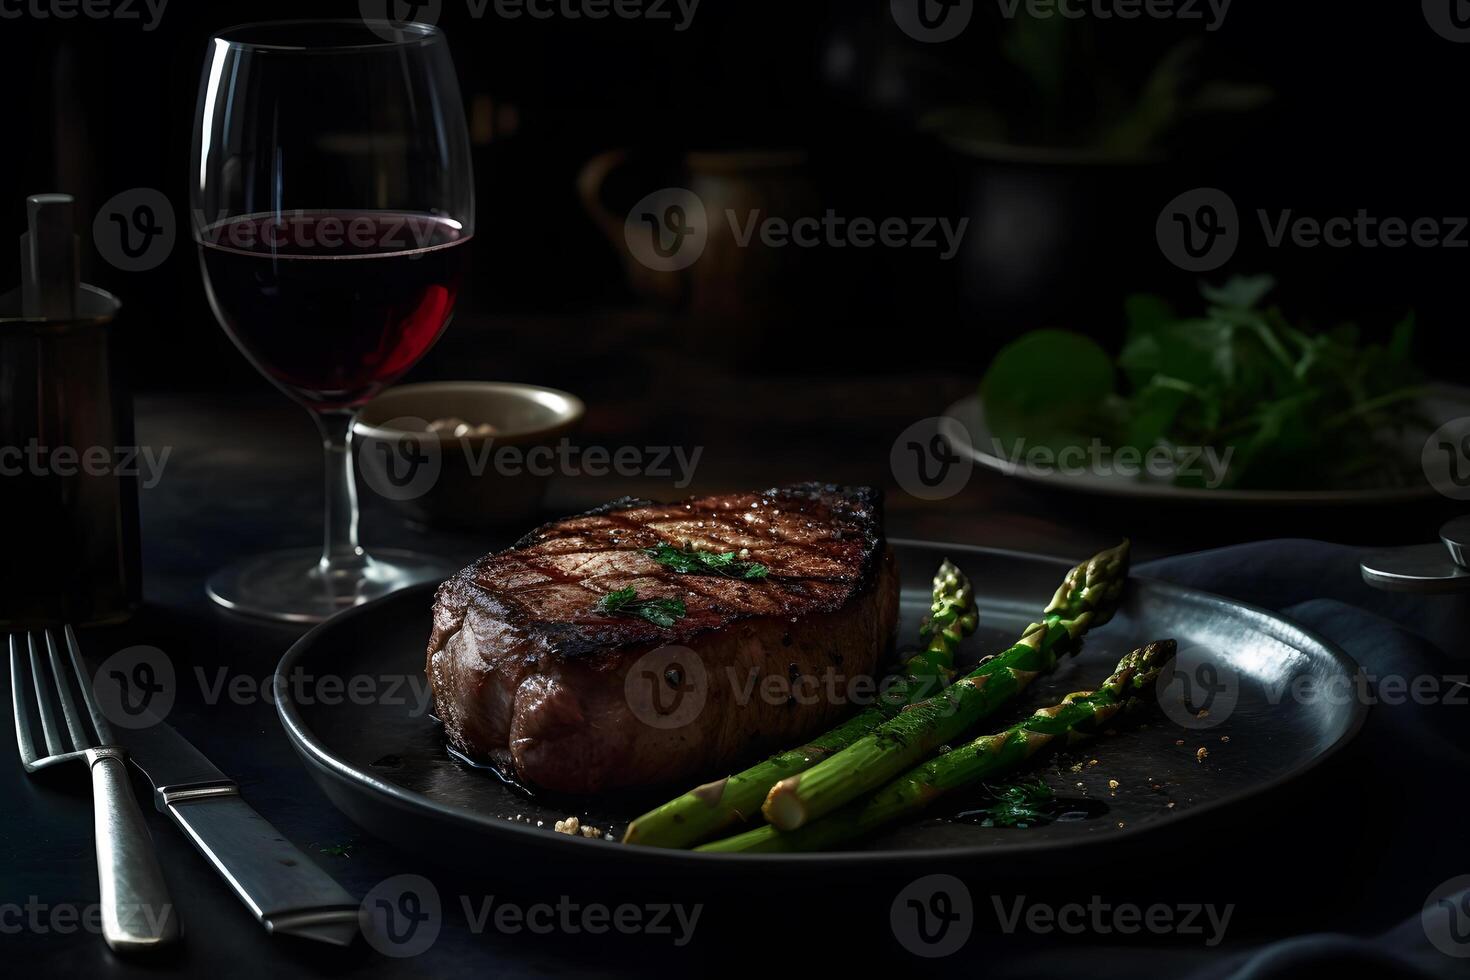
(1007, 541, 1470, 980)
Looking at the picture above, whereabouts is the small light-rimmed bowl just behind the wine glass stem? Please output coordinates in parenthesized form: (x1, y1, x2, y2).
(353, 381, 585, 529)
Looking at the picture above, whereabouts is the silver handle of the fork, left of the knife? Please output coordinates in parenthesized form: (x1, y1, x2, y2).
(87, 748, 179, 952)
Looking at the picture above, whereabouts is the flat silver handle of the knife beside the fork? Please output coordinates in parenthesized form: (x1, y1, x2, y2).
(159, 785, 359, 945)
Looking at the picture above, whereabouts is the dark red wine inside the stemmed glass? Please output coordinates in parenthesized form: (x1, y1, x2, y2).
(200, 212, 469, 408)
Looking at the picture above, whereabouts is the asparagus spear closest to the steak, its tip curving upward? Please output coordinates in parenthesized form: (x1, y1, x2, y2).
(623, 560, 978, 848)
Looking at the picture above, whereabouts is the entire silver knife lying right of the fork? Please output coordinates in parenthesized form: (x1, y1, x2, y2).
(122, 716, 359, 946)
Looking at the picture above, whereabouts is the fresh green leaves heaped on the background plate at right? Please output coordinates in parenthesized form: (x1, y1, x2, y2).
(980, 276, 1433, 489)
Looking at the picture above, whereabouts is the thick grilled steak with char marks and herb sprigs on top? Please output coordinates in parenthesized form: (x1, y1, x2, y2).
(426, 483, 898, 793)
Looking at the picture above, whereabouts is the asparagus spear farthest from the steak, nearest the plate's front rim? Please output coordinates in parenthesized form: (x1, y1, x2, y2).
(698, 639, 1175, 852)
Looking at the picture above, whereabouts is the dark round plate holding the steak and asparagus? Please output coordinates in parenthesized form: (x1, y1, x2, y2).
(276, 541, 1366, 873)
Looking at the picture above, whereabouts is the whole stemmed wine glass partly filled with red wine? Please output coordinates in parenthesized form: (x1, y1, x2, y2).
(190, 21, 475, 621)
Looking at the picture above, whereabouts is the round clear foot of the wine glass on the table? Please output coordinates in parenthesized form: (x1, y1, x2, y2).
(204, 548, 454, 623)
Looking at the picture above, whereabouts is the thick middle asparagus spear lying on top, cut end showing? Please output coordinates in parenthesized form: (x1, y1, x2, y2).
(761, 541, 1127, 830)
